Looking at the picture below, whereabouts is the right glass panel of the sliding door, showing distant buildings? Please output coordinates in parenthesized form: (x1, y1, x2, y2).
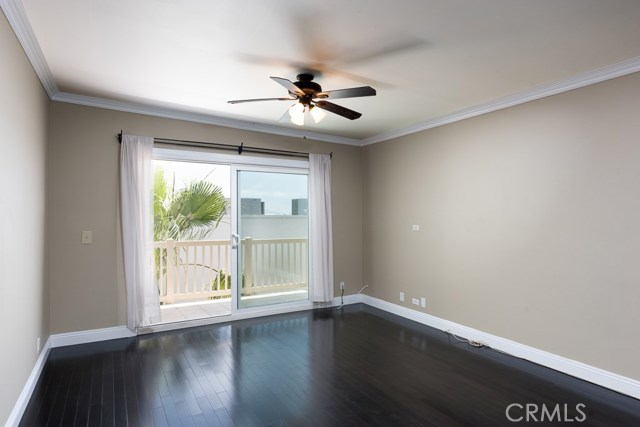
(232, 167, 309, 309)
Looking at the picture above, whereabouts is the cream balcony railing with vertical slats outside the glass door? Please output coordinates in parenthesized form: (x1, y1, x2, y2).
(154, 237, 309, 304)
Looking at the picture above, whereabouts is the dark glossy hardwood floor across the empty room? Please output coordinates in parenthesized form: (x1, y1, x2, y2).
(20, 304, 640, 427)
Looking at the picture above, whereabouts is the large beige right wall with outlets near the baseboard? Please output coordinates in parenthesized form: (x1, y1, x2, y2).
(363, 74, 640, 379)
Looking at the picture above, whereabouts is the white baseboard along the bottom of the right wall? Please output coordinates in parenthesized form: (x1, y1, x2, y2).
(362, 295, 640, 399)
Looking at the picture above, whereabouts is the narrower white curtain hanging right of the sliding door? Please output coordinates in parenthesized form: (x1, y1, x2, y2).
(309, 154, 333, 302)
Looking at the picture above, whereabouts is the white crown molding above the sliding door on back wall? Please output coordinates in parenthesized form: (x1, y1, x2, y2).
(51, 92, 361, 146)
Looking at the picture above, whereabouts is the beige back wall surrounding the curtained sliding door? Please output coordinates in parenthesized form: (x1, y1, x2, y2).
(49, 102, 362, 333)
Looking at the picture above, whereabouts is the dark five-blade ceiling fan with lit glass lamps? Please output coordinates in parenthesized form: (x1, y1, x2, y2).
(228, 73, 376, 125)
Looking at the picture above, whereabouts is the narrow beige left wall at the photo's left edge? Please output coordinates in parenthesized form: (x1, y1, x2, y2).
(0, 13, 49, 425)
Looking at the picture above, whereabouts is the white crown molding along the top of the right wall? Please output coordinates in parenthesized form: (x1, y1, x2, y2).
(361, 57, 640, 146)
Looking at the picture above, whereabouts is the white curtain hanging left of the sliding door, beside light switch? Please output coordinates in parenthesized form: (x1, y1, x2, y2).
(120, 135, 160, 332)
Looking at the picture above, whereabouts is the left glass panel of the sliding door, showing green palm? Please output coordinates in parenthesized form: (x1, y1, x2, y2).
(153, 160, 233, 323)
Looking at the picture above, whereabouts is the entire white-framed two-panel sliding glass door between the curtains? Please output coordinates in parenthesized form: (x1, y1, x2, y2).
(153, 148, 309, 323)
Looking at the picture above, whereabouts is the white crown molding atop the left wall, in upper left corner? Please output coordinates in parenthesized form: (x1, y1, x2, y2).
(0, 0, 58, 98)
